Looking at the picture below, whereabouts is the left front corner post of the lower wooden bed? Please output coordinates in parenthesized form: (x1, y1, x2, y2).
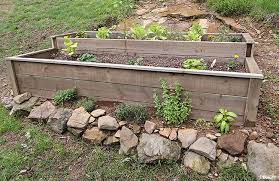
(6, 59, 20, 96)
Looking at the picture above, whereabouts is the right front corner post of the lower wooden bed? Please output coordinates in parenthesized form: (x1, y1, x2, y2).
(245, 79, 262, 126)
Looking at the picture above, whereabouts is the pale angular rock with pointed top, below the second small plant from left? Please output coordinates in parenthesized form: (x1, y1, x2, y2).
(67, 107, 90, 130)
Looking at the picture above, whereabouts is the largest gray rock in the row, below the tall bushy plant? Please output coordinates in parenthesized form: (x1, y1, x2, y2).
(137, 133, 181, 163)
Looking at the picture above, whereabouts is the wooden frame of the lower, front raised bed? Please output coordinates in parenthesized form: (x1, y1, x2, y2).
(7, 48, 263, 125)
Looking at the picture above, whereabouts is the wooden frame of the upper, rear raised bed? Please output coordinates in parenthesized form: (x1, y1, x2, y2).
(52, 31, 255, 61)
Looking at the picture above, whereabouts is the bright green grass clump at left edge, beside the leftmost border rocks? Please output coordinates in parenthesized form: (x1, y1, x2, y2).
(0, 105, 22, 136)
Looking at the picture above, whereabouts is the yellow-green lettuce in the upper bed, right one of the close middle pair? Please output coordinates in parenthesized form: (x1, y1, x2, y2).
(148, 23, 168, 40)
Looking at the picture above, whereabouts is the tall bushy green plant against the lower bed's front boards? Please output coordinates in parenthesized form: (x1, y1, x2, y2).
(153, 79, 191, 124)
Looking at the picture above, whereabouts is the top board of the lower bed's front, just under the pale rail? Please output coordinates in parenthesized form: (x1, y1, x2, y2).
(14, 61, 249, 97)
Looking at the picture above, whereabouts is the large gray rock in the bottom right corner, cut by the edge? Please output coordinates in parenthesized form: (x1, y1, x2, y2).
(247, 141, 279, 180)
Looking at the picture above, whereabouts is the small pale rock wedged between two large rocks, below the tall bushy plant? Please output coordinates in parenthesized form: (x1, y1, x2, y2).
(178, 129, 198, 148)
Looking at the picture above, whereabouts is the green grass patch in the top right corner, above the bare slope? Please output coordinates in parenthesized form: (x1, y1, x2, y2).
(207, 0, 279, 20)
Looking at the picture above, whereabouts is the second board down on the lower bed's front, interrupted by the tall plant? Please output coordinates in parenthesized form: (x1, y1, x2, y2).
(18, 75, 246, 115)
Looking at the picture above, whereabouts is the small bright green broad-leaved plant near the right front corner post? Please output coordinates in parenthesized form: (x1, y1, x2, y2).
(214, 108, 237, 133)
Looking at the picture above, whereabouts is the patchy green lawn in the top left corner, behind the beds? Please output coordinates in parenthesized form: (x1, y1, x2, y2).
(0, 0, 134, 62)
